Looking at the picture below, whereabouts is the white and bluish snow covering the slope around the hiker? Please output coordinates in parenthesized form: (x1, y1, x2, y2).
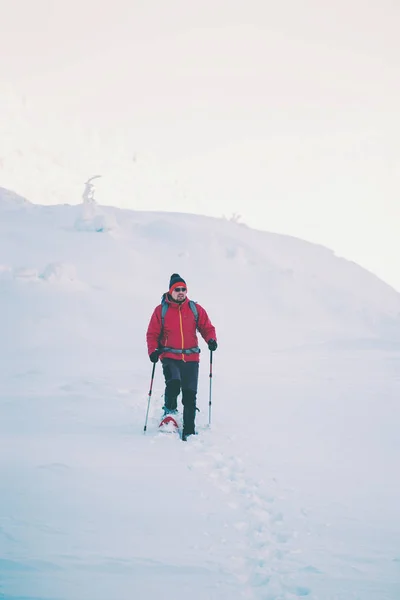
(0, 190, 400, 600)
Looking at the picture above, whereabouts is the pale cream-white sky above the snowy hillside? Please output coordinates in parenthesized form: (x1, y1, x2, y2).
(0, 0, 400, 291)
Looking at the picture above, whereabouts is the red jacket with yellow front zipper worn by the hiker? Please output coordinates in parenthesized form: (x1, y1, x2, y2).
(146, 294, 217, 362)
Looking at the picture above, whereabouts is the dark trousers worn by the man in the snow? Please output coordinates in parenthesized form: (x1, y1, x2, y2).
(162, 358, 199, 435)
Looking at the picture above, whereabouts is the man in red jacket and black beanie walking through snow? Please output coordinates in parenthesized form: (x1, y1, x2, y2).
(147, 273, 217, 440)
